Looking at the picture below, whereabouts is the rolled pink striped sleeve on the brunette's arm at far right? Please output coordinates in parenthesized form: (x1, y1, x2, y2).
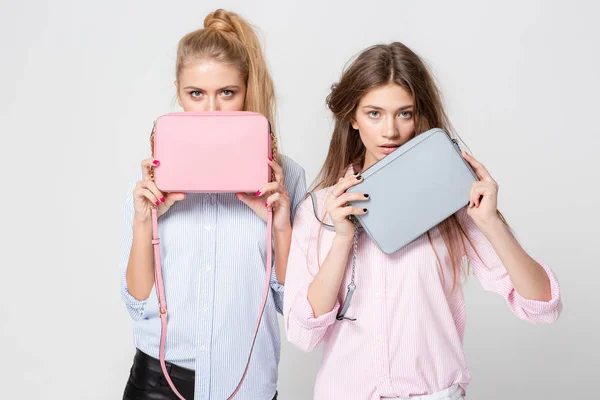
(457, 208, 562, 324)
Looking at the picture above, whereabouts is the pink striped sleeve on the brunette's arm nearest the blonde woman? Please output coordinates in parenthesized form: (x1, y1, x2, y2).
(283, 199, 340, 351)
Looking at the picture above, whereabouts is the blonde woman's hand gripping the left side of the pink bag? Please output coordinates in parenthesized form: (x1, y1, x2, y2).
(133, 158, 185, 222)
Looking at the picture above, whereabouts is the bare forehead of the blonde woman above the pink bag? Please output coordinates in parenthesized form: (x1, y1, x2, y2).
(179, 60, 245, 90)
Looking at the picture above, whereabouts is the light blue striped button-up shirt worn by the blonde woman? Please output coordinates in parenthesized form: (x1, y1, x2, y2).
(119, 156, 306, 400)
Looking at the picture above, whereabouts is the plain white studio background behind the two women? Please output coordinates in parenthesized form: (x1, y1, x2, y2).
(0, 0, 600, 400)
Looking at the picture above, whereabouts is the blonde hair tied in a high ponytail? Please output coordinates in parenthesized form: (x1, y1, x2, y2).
(170, 9, 279, 163)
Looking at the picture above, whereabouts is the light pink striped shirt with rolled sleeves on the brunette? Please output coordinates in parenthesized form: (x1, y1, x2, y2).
(284, 185, 562, 400)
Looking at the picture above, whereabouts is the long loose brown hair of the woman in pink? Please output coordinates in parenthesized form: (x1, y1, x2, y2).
(313, 42, 504, 289)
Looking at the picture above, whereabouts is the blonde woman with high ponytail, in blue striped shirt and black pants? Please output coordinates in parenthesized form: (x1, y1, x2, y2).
(120, 10, 306, 400)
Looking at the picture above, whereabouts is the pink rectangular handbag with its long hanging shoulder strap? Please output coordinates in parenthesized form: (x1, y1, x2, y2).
(152, 111, 273, 400)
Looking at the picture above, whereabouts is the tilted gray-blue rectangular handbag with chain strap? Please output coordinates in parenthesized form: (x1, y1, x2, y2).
(311, 128, 477, 319)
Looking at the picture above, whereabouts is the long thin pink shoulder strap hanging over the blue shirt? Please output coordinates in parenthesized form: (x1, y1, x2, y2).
(152, 208, 273, 400)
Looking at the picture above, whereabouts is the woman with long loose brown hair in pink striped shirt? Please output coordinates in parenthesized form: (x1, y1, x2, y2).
(284, 43, 562, 400)
